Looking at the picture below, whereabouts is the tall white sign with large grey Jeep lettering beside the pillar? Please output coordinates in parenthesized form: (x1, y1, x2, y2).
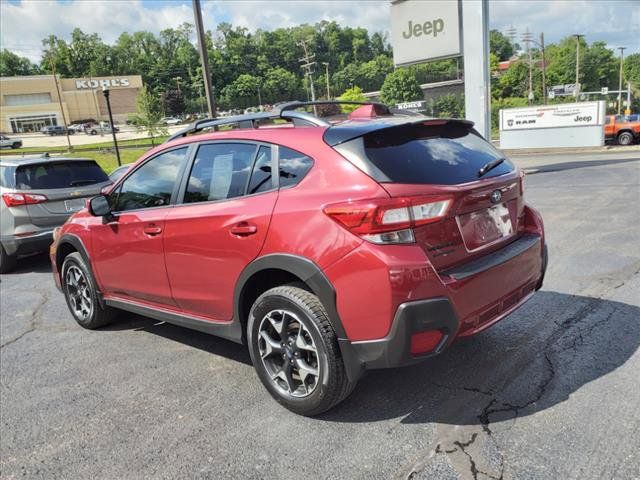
(391, 0, 461, 66)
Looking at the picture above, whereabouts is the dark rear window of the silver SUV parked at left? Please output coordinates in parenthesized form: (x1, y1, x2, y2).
(16, 160, 109, 190)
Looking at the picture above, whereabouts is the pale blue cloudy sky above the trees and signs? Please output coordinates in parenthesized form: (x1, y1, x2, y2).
(0, 0, 640, 62)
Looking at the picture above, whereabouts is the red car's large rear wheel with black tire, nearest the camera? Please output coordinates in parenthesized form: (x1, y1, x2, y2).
(247, 286, 356, 416)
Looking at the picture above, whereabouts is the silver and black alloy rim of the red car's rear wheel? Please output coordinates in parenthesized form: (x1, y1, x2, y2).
(258, 310, 320, 398)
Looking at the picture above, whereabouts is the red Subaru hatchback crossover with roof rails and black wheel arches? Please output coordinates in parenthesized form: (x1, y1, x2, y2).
(51, 104, 547, 415)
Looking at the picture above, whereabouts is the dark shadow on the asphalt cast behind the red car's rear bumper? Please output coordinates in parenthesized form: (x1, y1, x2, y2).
(320, 291, 640, 427)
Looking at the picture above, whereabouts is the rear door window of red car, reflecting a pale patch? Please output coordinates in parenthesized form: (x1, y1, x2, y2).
(184, 143, 256, 203)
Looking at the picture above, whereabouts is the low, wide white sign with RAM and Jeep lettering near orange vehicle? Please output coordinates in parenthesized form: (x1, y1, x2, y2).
(500, 102, 602, 131)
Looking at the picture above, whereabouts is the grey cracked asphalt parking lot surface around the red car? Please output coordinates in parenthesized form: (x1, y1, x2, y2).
(0, 151, 640, 480)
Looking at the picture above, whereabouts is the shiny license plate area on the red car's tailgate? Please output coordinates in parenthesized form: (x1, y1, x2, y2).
(458, 203, 513, 251)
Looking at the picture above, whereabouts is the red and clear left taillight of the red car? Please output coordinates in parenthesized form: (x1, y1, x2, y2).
(324, 197, 452, 244)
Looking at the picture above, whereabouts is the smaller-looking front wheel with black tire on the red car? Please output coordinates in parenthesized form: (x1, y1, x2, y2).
(61, 252, 116, 330)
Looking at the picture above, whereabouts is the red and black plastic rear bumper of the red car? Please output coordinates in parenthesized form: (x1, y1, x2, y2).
(339, 235, 547, 378)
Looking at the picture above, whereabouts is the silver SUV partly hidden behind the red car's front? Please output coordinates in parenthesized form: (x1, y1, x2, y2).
(0, 156, 111, 273)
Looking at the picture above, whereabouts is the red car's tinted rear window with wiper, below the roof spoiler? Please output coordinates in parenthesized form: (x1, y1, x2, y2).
(355, 124, 514, 185)
